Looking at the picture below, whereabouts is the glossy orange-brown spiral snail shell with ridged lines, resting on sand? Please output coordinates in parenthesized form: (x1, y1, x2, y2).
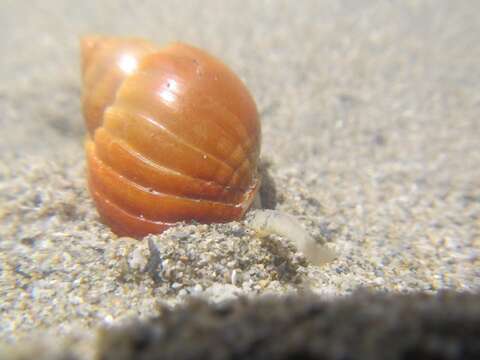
(81, 36, 261, 238)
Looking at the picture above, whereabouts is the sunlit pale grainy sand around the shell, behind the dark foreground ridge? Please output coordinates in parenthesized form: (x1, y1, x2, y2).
(0, 0, 480, 352)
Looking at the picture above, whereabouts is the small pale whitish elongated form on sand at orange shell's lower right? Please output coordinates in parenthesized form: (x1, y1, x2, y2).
(247, 210, 336, 266)
